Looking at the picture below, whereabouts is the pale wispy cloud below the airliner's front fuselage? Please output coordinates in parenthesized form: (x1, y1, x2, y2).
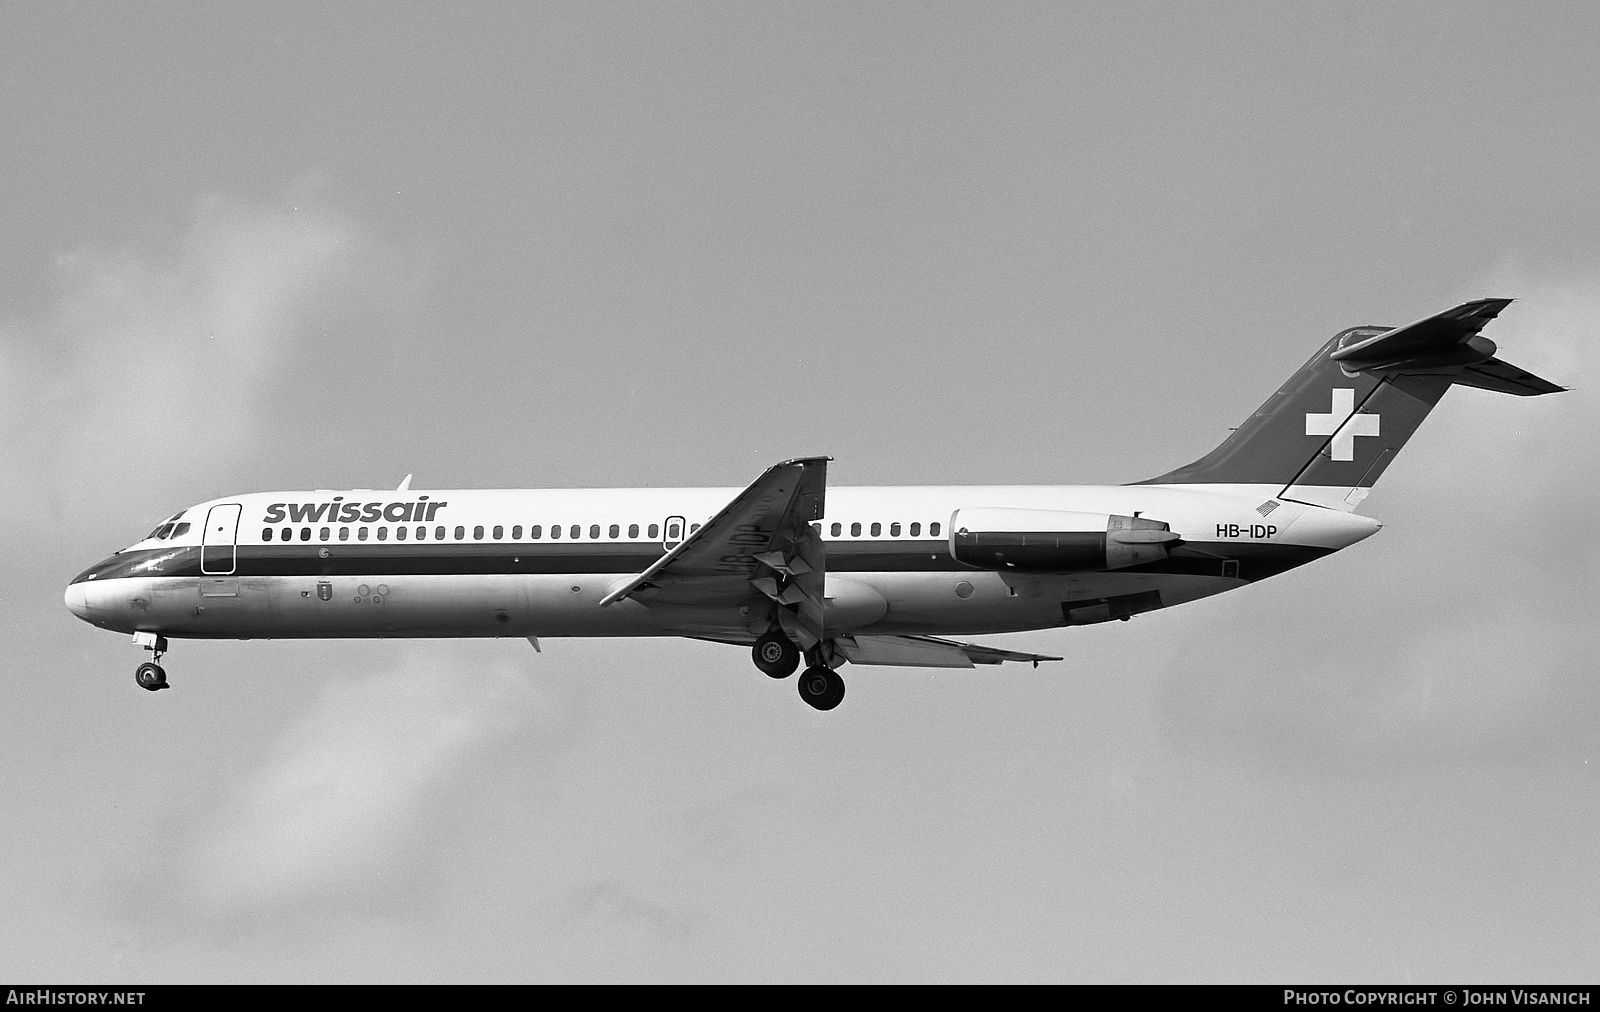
(134, 649, 570, 926)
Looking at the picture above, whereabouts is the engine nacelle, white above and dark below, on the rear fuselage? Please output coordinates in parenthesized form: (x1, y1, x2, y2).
(950, 506, 1179, 573)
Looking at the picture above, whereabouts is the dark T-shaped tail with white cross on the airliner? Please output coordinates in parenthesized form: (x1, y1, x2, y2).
(1138, 299, 1565, 511)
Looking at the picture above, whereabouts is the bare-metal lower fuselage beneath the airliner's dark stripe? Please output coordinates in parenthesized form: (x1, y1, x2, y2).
(84, 570, 1240, 639)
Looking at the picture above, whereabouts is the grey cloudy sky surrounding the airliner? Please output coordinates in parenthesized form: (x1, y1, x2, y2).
(0, 3, 1600, 983)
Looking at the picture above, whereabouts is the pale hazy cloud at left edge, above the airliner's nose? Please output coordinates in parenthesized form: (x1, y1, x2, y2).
(0, 192, 412, 533)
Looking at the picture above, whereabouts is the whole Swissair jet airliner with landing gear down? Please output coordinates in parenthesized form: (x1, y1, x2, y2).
(66, 299, 1563, 709)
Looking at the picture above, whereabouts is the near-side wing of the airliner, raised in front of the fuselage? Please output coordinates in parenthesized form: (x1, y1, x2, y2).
(600, 456, 829, 649)
